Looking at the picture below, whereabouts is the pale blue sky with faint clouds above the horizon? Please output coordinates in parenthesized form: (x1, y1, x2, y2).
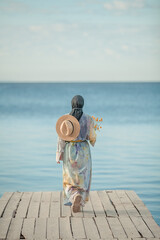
(0, 0, 160, 82)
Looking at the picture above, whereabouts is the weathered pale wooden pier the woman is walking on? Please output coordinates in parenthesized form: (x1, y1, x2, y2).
(0, 190, 160, 240)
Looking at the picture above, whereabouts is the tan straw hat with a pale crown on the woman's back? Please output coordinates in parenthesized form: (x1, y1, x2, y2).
(56, 114, 80, 141)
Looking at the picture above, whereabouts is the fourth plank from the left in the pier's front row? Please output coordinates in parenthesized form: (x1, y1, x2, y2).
(34, 218, 46, 240)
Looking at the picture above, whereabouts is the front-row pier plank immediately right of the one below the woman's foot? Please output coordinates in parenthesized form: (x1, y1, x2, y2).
(83, 218, 100, 239)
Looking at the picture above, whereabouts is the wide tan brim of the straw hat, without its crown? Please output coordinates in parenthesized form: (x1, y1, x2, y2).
(56, 114, 80, 141)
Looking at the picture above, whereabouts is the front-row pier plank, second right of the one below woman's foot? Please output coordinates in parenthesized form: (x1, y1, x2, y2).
(94, 217, 113, 239)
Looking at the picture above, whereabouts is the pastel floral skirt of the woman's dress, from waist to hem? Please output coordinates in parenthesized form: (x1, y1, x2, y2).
(63, 141, 92, 206)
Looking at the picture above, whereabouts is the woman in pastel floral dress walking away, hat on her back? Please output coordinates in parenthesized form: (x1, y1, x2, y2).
(56, 95, 96, 212)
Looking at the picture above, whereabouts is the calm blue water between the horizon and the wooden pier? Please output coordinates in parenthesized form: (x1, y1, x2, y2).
(0, 83, 160, 224)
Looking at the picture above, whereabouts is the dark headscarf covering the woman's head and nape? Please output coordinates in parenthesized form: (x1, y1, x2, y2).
(70, 95, 84, 121)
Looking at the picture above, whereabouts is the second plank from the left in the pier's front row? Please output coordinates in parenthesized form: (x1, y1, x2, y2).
(7, 218, 23, 240)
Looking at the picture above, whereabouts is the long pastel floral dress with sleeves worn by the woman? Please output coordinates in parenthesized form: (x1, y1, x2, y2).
(56, 113, 96, 206)
